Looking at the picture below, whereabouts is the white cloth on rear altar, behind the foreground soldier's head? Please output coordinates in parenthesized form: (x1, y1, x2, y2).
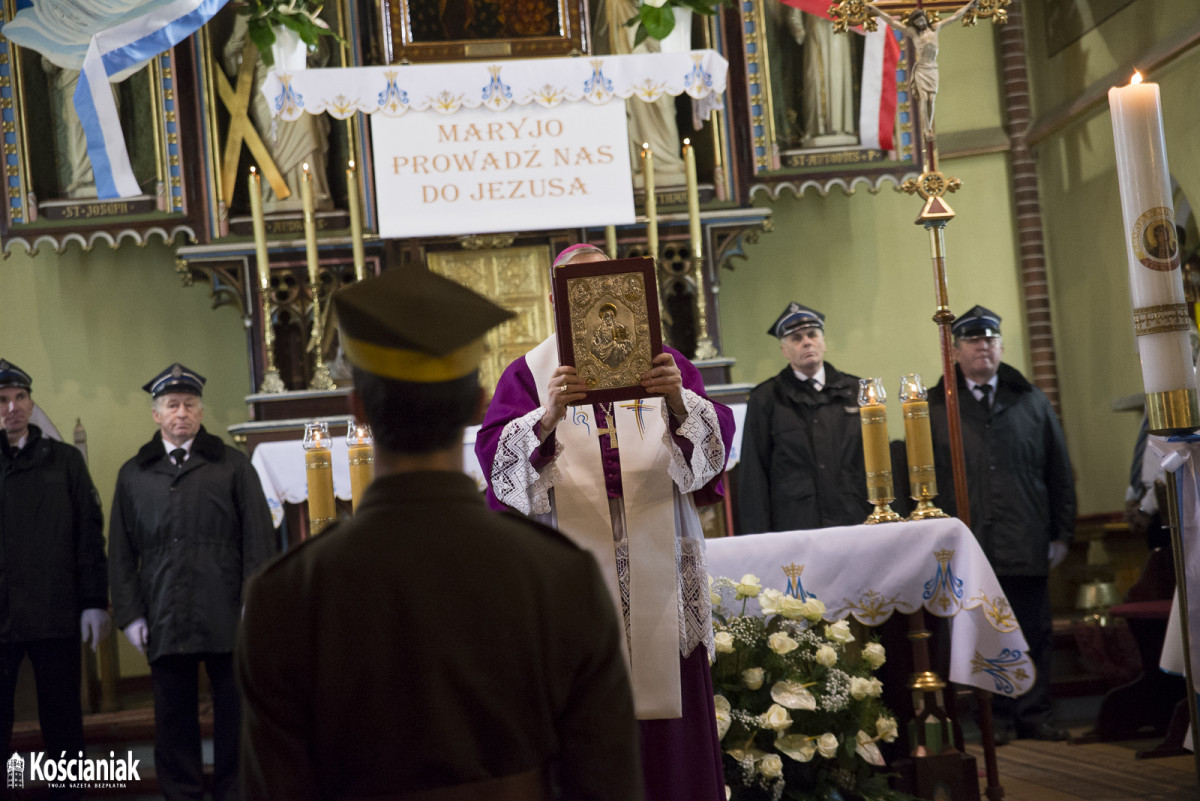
(250, 426, 485, 526)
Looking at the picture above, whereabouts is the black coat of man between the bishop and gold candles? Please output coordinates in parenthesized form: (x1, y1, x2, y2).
(738, 362, 871, 534)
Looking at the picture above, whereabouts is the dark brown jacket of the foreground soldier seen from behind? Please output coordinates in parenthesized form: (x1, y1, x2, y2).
(235, 471, 642, 801)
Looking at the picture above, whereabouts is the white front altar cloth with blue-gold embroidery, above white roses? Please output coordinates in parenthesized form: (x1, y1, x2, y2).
(707, 518, 1034, 697)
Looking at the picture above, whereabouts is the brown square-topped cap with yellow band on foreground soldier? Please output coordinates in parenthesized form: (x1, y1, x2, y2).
(334, 267, 516, 384)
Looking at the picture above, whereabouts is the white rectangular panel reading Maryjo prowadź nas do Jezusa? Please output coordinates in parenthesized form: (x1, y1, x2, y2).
(371, 103, 635, 239)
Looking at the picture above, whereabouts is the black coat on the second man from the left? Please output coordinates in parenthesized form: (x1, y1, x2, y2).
(108, 427, 276, 662)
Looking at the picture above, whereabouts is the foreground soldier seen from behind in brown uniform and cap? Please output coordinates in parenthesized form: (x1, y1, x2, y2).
(238, 267, 642, 801)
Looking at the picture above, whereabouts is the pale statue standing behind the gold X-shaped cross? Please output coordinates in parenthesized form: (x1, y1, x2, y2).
(222, 14, 334, 213)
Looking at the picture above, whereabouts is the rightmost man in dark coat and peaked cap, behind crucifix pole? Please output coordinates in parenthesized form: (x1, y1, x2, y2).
(929, 306, 1075, 742)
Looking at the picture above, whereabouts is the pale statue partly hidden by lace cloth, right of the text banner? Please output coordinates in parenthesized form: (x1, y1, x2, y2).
(593, 0, 686, 187)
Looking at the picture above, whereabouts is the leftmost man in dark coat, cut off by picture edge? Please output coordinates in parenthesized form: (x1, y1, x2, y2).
(0, 359, 112, 797)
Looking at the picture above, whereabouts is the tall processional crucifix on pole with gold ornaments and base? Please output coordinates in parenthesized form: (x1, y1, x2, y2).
(829, 0, 1009, 801)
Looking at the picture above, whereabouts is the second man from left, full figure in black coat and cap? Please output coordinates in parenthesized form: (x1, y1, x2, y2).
(108, 363, 276, 801)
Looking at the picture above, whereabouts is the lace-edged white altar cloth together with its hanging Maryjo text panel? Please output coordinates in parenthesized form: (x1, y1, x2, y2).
(262, 50, 728, 239)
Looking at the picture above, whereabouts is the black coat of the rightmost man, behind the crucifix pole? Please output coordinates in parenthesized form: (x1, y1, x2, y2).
(929, 362, 1075, 576)
